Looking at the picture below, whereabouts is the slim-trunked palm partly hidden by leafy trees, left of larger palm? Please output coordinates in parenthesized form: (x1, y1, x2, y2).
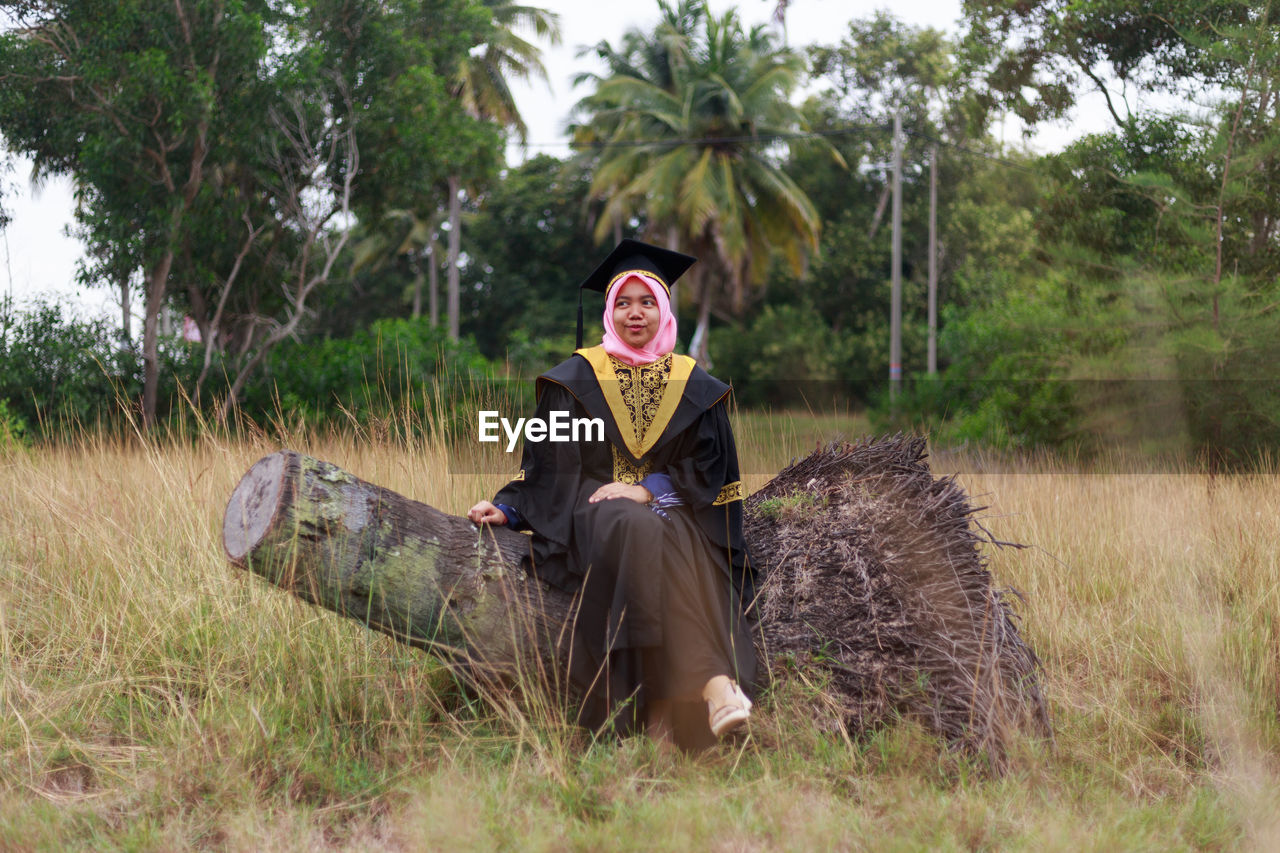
(445, 0, 559, 339)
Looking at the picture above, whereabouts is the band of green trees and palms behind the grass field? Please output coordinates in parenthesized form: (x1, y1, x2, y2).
(12, 0, 1280, 464)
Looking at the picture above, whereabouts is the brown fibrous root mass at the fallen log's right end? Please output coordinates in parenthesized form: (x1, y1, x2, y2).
(745, 435, 1051, 770)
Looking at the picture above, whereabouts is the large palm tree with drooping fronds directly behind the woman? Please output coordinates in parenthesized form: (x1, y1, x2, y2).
(575, 0, 838, 364)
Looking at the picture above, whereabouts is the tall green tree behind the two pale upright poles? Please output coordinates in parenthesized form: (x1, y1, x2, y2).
(765, 13, 993, 402)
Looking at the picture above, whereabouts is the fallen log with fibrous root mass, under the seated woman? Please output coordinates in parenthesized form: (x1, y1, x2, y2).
(223, 435, 1050, 767)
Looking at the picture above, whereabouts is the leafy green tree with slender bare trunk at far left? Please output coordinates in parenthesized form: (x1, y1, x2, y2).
(0, 0, 270, 424)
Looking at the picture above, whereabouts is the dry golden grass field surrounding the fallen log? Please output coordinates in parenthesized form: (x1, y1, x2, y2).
(0, 415, 1280, 852)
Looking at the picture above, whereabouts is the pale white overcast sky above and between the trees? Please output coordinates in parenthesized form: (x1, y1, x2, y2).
(0, 0, 1107, 319)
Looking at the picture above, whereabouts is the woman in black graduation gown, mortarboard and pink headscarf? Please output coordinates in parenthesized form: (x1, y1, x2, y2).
(467, 240, 755, 748)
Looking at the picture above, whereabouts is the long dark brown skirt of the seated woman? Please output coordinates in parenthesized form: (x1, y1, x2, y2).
(570, 492, 756, 748)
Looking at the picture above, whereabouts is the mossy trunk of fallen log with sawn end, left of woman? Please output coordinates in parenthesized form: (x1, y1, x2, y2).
(223, 451, 572, 670)
